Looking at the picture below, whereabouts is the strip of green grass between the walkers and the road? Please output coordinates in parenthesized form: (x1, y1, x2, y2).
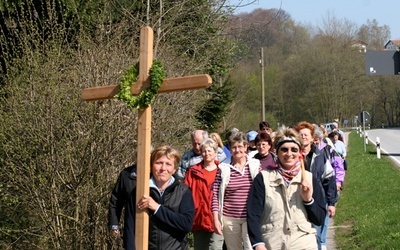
(335, 131, 400, 249)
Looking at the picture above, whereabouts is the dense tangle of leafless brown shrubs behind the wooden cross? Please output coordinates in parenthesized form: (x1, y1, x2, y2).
(0, 0, 238, 249)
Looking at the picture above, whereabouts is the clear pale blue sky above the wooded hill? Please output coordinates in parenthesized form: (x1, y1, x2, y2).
(229, 0, 400, 39)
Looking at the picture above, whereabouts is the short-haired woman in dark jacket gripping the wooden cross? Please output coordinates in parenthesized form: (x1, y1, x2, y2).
(136, 146, 194, 250)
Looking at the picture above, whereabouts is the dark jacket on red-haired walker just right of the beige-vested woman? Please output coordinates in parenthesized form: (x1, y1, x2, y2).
(305, 144, 338, 206)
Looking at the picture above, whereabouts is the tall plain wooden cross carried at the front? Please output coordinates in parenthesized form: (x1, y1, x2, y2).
(82, 26, 212, 250)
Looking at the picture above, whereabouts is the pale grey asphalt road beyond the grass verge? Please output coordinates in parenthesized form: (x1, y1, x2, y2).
(365, 128, 400, 166)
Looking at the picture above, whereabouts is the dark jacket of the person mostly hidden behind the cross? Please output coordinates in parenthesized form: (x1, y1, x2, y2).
(108, 165, 136, 250)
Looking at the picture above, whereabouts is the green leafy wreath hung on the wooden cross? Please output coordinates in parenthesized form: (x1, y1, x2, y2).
(114, 60, 165, 109)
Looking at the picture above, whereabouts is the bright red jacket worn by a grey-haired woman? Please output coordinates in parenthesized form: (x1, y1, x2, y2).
(185, 161, 219, 232)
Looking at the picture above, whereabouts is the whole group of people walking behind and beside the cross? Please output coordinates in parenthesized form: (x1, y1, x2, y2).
(109, 122, 345, 250)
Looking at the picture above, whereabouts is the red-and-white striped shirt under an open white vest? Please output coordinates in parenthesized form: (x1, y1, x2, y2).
(212, 165, 253, 219)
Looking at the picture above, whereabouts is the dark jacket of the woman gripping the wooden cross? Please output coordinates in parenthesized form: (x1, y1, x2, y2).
(149, 179, 194, 250)
